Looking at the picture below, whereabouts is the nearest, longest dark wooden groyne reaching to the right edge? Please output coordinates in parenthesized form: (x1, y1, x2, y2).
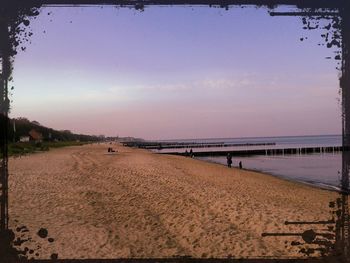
(159, 146, 343, 157)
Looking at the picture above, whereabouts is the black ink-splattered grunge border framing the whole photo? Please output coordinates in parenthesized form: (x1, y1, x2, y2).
(0, 0, 350, 263)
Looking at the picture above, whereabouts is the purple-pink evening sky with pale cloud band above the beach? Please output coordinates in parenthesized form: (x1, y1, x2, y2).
(10, 6, 341, 140)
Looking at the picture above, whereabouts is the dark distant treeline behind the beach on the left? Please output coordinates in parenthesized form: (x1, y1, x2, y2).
(8, 117, 101, 142)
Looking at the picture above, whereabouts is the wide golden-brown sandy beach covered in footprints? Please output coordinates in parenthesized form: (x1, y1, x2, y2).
(9, 144, 337, 258)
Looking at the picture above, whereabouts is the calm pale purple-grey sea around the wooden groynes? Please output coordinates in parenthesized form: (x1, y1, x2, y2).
(154, 135, 342, 190)
